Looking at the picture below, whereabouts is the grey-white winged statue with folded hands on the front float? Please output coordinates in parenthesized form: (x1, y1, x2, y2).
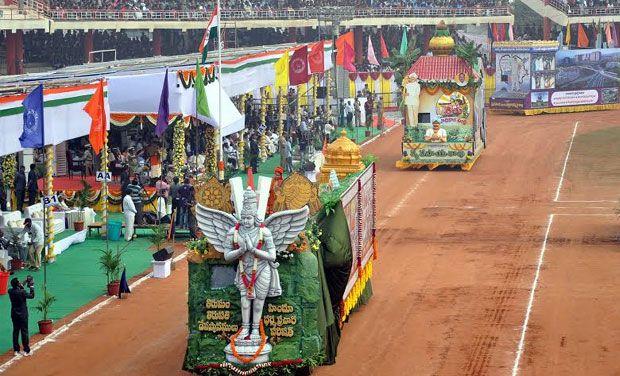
(196, 188, 310, 364)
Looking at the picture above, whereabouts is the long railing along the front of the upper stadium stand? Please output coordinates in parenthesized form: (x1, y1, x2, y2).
(49, 7, 511, 21)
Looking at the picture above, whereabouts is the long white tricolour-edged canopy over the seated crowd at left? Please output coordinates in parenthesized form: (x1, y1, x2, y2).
(0, 41, 333, 156)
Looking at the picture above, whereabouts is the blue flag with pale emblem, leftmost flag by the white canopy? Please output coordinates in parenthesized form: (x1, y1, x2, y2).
(19, 85, 45, 148)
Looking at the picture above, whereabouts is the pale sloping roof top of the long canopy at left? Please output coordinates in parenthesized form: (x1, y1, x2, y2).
(0, 43, 295, 97)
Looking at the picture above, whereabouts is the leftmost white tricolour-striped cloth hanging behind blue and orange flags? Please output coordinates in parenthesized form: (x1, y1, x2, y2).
(0, 84, 110, 156)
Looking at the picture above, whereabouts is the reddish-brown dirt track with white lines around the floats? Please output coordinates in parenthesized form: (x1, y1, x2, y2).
(4, 111, 620, 376)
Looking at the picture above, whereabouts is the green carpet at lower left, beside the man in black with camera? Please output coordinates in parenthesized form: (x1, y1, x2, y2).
(0, 231, 152, 352)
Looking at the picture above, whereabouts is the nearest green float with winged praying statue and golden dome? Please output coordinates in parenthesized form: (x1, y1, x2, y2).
(184, 131, 377, 375)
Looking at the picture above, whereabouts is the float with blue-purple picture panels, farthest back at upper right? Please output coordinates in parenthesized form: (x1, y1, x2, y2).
(490, 41, 620, 115)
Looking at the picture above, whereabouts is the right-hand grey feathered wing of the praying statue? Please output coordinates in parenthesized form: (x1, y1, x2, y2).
(265, 206, 310, 252)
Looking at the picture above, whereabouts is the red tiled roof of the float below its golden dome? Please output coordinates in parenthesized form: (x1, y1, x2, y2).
(407, 55, 473, 82)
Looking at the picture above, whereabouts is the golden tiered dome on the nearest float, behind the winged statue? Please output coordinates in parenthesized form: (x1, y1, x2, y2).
(320, 130, 364, 183)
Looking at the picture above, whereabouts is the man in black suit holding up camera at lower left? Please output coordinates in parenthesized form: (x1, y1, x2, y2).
(9, 275, 34, 356)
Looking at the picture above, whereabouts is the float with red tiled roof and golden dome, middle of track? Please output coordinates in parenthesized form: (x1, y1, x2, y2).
(396, 21, 486, 171)
